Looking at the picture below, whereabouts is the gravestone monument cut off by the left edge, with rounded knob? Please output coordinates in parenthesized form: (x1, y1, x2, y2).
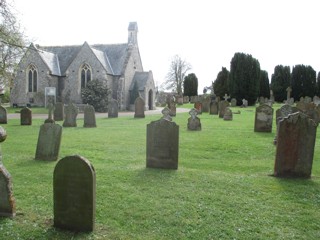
(0, 126, 16, 217)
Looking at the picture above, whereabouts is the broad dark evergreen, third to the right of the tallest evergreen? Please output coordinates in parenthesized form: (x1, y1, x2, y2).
(291, 64, 317, 101)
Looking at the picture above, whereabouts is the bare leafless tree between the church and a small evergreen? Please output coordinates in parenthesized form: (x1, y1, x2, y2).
(163, 55, 191, 95)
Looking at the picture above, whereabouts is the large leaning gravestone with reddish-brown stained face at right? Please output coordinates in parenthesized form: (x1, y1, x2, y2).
(274, 112, 317, 178)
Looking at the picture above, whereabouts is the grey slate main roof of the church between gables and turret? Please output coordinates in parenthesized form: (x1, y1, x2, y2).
(38, 43, 128, 76)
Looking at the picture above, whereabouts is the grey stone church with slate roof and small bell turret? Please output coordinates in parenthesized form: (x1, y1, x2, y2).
(10, 22, 155, 110)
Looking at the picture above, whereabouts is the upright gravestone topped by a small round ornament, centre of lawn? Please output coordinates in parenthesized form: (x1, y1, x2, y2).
(146, 108, 179, 169)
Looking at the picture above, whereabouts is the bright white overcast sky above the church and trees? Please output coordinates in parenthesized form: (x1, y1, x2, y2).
(11, 0, 320, 94)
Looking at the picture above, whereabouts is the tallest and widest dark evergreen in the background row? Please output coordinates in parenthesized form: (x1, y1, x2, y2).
(229, 53, 260, 105)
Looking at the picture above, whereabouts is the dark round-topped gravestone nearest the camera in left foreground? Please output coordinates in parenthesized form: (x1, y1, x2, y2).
(53, 155, 96, 232)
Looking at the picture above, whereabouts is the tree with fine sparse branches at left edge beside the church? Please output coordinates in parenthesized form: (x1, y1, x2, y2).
(0, 0, 25, 87)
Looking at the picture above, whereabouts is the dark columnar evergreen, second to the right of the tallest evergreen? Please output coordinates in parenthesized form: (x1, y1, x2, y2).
(271, 65, 290, 102)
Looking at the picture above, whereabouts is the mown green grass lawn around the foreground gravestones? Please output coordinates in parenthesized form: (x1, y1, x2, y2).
(0, 105, 320, 239)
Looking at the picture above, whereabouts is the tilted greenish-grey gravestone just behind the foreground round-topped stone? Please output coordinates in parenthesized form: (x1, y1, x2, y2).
(35, 123, 62, 161)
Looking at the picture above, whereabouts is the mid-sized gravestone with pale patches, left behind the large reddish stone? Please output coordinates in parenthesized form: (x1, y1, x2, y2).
(254, 104, 273, 132)
